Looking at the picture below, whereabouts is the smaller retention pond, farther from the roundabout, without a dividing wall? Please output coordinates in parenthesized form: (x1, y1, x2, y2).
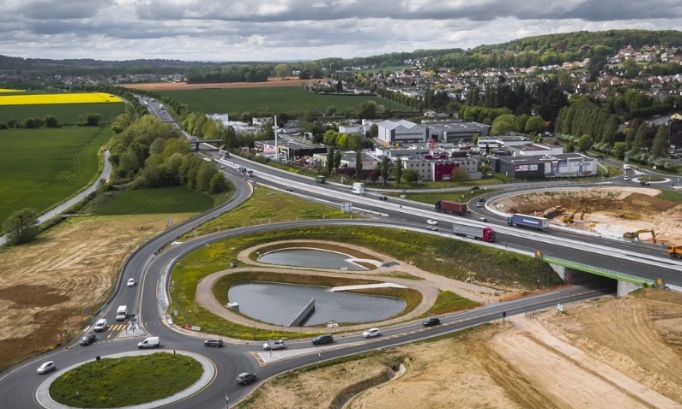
(258, 248, 367, 271)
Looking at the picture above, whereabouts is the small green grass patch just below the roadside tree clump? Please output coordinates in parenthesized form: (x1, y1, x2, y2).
(94, 186, 213, 216)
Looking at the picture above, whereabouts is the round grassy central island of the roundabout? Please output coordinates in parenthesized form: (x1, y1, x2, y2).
(50, 352, 203, 408)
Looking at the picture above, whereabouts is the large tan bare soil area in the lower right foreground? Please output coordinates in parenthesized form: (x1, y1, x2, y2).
(239, 289, 682, 409)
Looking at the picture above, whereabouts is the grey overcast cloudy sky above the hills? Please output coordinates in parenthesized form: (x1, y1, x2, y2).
(0, 0, 682, 61)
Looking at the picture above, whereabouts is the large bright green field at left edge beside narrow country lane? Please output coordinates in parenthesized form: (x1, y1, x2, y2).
(0, 127, 112, 228)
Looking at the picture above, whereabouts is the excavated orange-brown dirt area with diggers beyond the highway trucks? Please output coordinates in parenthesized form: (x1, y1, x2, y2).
(490, 187, 682, 244)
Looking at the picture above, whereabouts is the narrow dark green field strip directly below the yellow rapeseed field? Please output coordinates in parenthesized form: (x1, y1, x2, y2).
(0, 103, 123, 125)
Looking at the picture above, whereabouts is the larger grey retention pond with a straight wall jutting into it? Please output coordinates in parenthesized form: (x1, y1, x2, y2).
(228, 283, 405, 326)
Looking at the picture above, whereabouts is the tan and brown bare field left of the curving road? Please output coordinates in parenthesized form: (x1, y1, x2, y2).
(0, 214, 191, 370)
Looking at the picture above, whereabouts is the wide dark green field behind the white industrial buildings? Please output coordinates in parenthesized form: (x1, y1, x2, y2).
(161, 87, 407, 113)
